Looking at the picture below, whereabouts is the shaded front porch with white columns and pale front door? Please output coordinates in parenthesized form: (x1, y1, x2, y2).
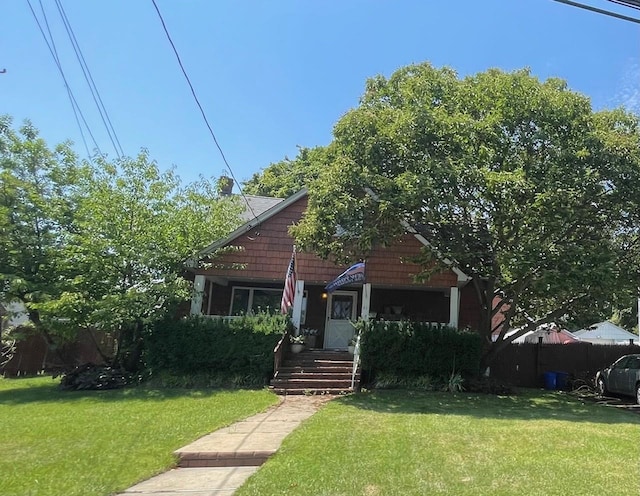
(191, 275, 461, 350)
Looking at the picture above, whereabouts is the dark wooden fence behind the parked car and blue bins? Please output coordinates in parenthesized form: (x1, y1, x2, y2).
(490, 343, 640, 387)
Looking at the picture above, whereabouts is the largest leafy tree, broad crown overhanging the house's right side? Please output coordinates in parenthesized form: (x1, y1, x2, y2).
(293, 63, 640, 364)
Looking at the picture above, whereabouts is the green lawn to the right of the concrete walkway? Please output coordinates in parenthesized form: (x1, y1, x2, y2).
(236, 391, 640, 496)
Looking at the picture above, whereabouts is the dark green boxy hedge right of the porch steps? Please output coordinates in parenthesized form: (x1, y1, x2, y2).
(359, 322, 482, 377)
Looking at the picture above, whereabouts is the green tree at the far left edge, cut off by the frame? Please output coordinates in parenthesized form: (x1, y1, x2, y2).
(0, 116, 88, 342)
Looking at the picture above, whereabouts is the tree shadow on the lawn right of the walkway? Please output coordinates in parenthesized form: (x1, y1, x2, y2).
(338, 390, 640, 424)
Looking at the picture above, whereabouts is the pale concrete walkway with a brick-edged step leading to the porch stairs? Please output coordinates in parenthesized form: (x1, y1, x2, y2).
(120, 396, 331, 496)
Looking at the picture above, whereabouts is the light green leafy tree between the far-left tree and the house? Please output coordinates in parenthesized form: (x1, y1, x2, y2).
(42, 151, 240, 369)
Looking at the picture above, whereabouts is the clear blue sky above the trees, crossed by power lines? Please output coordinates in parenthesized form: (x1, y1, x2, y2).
(0, 0, 640, 188)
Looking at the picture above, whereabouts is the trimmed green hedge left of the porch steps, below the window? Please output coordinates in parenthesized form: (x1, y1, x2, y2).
(144, 314, 290, 383)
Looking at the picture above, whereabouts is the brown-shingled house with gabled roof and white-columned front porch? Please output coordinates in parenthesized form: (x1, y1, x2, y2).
(190, 190, 479, 349)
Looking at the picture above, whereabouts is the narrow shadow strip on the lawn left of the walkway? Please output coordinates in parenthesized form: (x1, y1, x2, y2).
(0, 378, 245, 405)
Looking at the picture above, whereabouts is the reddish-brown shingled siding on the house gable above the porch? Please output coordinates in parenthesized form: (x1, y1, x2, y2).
(200, 197, 457, 288)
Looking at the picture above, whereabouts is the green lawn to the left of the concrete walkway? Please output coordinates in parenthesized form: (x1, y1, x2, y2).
(0, 377, 277, 496)
